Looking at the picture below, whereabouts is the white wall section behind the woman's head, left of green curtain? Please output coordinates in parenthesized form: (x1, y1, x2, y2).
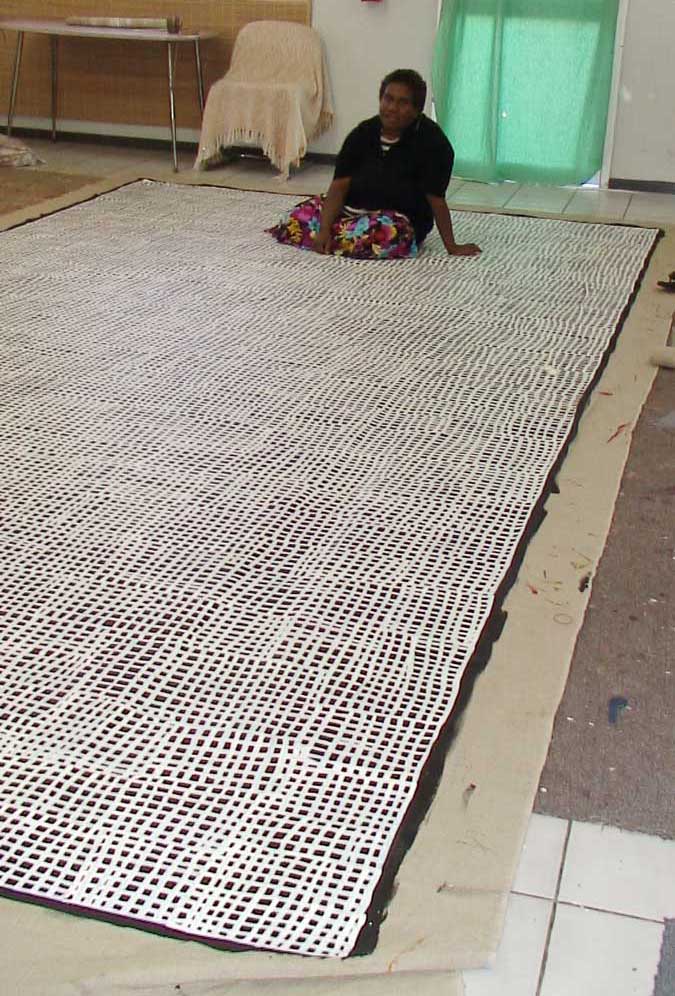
(310, 0, 438, 153)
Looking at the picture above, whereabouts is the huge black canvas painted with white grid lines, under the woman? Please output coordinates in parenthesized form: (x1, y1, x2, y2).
(0, 182, 656, 957)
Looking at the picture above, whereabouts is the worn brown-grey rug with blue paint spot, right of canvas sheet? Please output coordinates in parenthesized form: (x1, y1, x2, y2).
(536, 369, 675, 838)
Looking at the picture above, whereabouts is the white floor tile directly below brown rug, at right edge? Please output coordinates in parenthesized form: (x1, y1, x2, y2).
(559, 822, 675, 920)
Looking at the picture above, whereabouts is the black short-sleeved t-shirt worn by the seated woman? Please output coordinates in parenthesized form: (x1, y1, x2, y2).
(335, 114, 455, 242)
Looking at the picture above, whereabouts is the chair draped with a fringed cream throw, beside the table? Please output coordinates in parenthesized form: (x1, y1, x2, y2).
(195, 21, 334, 179)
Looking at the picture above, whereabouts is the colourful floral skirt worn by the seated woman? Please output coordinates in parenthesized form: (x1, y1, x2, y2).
(267, 195, 417, 259)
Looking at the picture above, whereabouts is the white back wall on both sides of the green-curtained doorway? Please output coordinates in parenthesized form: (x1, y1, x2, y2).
(310, 0, 675, 182)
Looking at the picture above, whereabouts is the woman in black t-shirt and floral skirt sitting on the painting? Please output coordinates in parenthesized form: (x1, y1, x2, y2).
(269, 69, 480, 259)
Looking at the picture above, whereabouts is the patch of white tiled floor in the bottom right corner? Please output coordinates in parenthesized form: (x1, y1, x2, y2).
(464, 814, 675, 996)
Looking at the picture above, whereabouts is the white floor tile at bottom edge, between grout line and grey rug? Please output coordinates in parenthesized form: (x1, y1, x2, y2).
(541, 906, 663, 996)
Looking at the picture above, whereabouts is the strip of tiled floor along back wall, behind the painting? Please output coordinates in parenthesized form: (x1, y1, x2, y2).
(21, 132, 675, 225)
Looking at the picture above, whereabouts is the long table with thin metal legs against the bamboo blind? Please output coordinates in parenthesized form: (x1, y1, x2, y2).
(0, 17, 217, 172)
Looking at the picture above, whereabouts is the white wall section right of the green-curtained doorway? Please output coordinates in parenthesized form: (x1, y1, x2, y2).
(609, 0, 675, 183)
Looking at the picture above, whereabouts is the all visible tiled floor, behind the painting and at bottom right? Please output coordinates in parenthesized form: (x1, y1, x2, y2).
(5, 134, 675, 996)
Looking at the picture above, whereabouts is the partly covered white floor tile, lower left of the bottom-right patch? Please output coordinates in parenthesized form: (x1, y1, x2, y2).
(464, 895, 556, 996)
